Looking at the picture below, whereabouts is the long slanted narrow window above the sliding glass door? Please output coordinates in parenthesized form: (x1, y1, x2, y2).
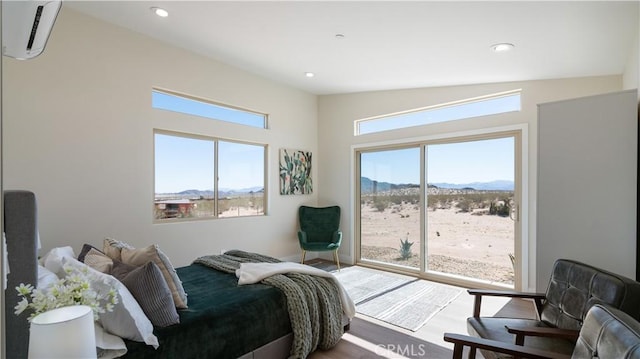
(355, 90, 520, 136)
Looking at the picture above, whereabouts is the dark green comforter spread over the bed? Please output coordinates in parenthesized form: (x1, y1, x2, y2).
(125, 264, 291, 359)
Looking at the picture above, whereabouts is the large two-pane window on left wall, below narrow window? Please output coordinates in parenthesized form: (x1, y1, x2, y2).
(154, 130, 267, 222)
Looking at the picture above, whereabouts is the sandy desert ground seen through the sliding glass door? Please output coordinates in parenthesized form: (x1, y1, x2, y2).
(361, 189, 514, 285)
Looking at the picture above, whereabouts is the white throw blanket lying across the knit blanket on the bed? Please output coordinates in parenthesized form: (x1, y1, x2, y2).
(236, 262, 356, 319)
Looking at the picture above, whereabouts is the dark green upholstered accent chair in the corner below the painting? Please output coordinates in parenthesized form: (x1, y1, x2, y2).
(298, 206, 342, 270)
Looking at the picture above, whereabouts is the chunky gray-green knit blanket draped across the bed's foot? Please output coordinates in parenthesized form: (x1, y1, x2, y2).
(194, 250, 353, 359)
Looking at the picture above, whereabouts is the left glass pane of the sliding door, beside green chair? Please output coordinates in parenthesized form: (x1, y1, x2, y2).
(360, 146, 422, 269)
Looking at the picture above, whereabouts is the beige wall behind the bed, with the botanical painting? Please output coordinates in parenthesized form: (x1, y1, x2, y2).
(3, 7, 321, 265)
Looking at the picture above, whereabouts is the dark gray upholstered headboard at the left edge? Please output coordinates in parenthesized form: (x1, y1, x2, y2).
(4, 190, 38, 359)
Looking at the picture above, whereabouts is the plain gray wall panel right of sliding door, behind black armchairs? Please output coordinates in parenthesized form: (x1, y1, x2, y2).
(537, 89, 638, 291)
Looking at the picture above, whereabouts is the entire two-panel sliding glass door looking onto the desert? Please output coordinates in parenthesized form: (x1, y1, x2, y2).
(356, 133, 520, 287)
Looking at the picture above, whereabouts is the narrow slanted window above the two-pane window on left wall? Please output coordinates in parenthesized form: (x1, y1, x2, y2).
(151, 89, 267, 128)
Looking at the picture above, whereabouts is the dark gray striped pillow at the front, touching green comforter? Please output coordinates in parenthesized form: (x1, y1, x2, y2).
(111, 261, 180, 327)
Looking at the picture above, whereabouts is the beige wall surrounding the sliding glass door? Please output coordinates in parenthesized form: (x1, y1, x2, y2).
(318, 76, 622, 287)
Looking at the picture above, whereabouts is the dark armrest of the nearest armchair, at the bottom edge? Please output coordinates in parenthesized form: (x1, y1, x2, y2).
(444, 333, 571, 359)
